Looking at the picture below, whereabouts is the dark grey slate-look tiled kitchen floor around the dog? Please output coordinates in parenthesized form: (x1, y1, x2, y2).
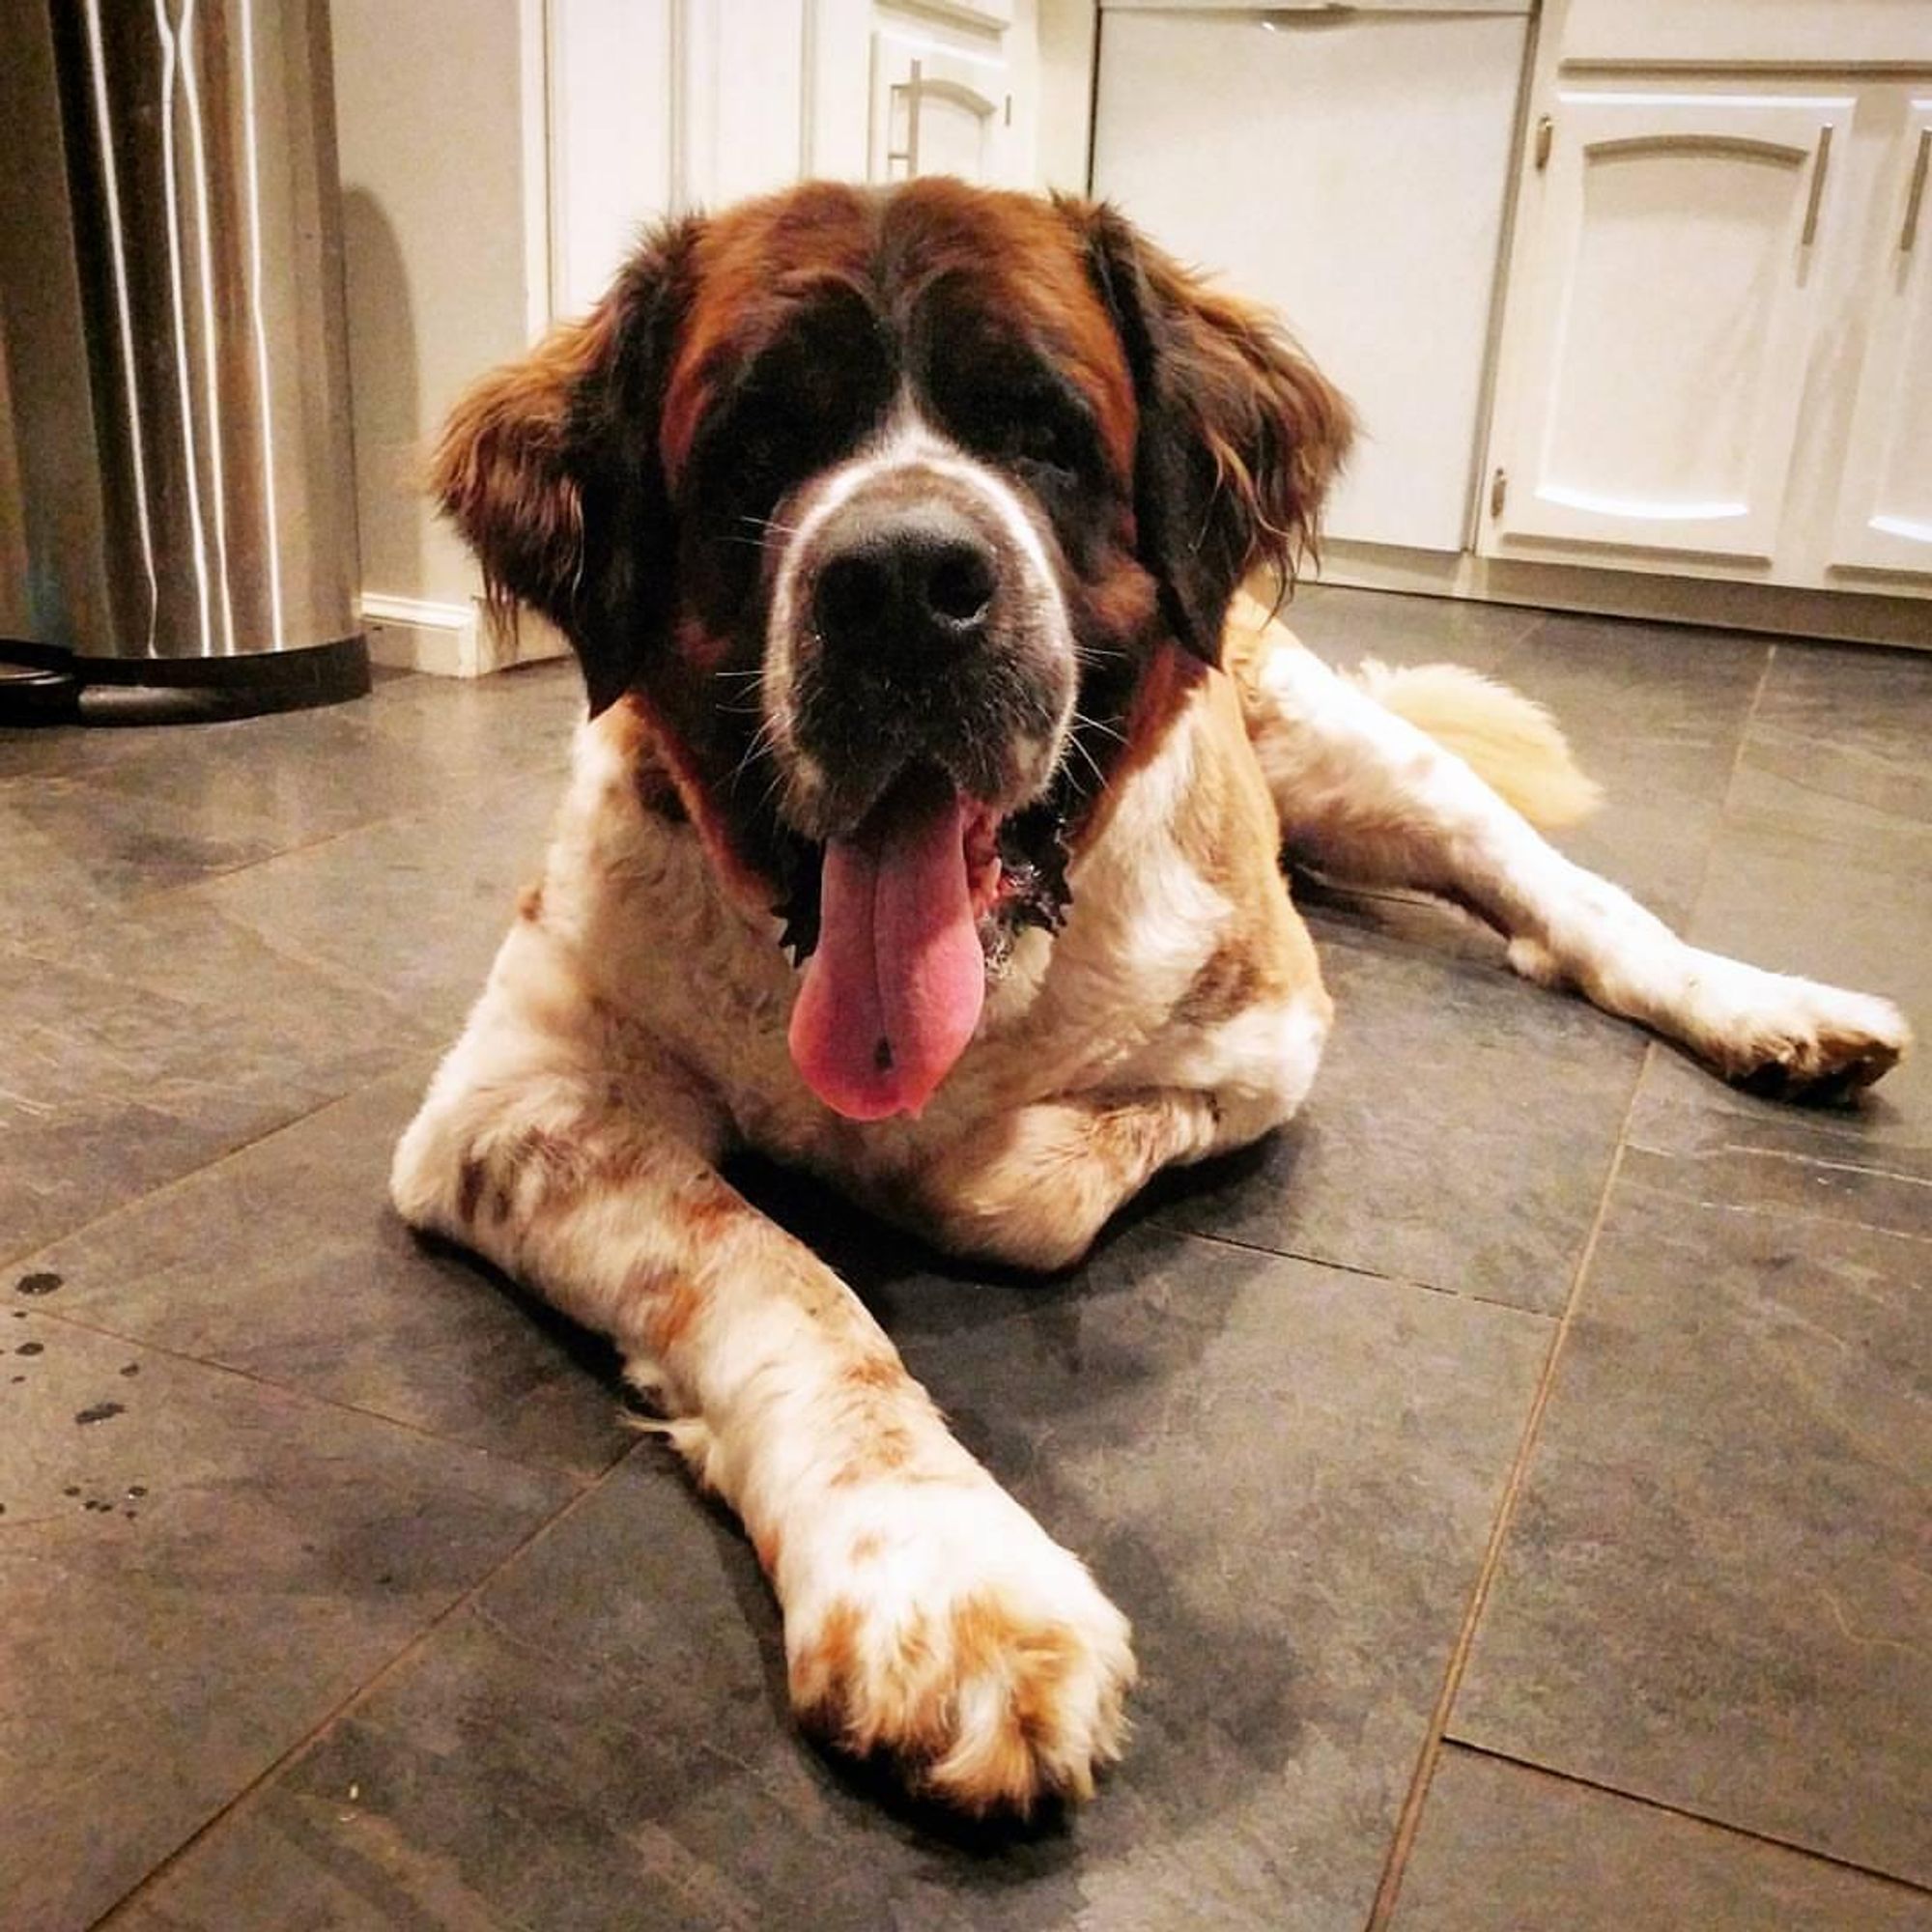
(0, 591, 1932, 1932)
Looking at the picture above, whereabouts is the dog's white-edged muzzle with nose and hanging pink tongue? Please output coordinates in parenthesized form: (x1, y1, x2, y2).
(765, 454, 1076, 1121)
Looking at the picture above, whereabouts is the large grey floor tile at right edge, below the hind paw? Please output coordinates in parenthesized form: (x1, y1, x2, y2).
(1451, 1150, 1932, 1882)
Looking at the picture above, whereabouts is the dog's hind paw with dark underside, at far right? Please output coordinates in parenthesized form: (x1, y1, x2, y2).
(1714, 962, 1913, 1101)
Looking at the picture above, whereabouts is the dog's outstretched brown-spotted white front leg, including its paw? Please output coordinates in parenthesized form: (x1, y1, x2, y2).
(394, 991, 1134, 1812)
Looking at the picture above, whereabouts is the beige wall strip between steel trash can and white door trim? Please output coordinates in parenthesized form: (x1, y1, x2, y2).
(332, 0, 541, 607)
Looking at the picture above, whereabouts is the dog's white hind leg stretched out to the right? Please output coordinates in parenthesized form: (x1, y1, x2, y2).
(1236, 630, 1911, 1097)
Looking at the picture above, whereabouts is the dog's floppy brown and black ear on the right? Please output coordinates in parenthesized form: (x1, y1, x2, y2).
(1061, 201, 1354, 663)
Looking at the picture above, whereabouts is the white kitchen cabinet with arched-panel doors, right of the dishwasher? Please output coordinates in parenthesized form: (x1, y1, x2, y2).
(1478, 16, 1932, 597)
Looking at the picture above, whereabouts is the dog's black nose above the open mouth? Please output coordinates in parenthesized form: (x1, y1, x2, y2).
(811, 504, 999, 655)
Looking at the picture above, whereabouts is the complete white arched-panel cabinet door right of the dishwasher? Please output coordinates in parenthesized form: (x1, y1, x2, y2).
(1490, 87, 1853, 560)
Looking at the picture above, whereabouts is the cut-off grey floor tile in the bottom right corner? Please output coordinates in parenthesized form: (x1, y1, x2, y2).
(1393, 1747, 1932, 1932)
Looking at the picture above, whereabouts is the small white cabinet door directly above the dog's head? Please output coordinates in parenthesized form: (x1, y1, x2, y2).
(869, 29, 1012, 184)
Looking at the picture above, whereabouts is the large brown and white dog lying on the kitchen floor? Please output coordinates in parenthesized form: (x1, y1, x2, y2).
(394, 182, 1907, 1810)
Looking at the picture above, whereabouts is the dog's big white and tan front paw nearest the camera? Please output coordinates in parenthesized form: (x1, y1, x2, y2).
(784, 1482, 1134, 1816)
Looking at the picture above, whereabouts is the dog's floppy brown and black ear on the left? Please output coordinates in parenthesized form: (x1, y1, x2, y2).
(429, 222, 697, 717)
